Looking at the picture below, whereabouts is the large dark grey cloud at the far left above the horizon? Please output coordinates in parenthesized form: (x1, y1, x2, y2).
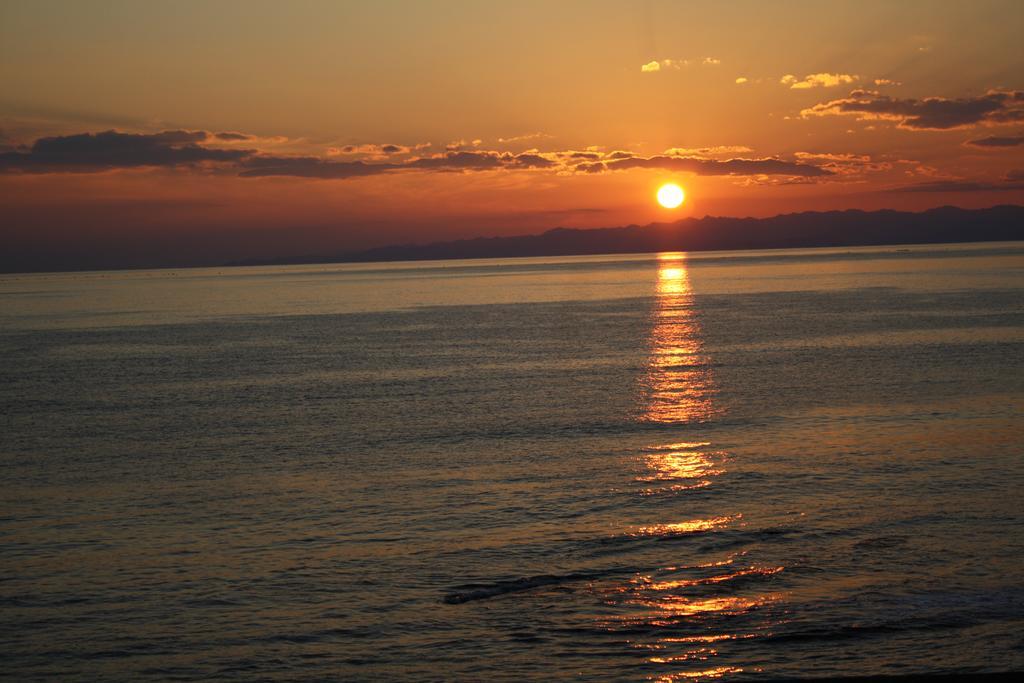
(0, 130, 253, 173)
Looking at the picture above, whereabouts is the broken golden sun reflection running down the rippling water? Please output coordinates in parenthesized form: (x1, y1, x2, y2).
(603, 253, 783, 681)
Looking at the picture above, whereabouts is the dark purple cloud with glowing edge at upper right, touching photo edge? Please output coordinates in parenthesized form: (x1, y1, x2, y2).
(800, 90, 1024, 130)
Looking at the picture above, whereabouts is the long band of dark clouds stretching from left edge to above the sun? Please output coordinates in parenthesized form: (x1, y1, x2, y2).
(0, 130, 839, 179)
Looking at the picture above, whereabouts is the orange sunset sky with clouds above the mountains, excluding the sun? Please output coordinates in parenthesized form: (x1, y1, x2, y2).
(0, 0, 1024, 269)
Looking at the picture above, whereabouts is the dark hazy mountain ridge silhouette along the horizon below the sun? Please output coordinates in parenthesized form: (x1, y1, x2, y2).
(232, 205, 1024, 265)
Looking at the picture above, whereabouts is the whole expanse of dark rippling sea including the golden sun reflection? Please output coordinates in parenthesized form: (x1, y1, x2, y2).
(0, 244, 1024, 681)
